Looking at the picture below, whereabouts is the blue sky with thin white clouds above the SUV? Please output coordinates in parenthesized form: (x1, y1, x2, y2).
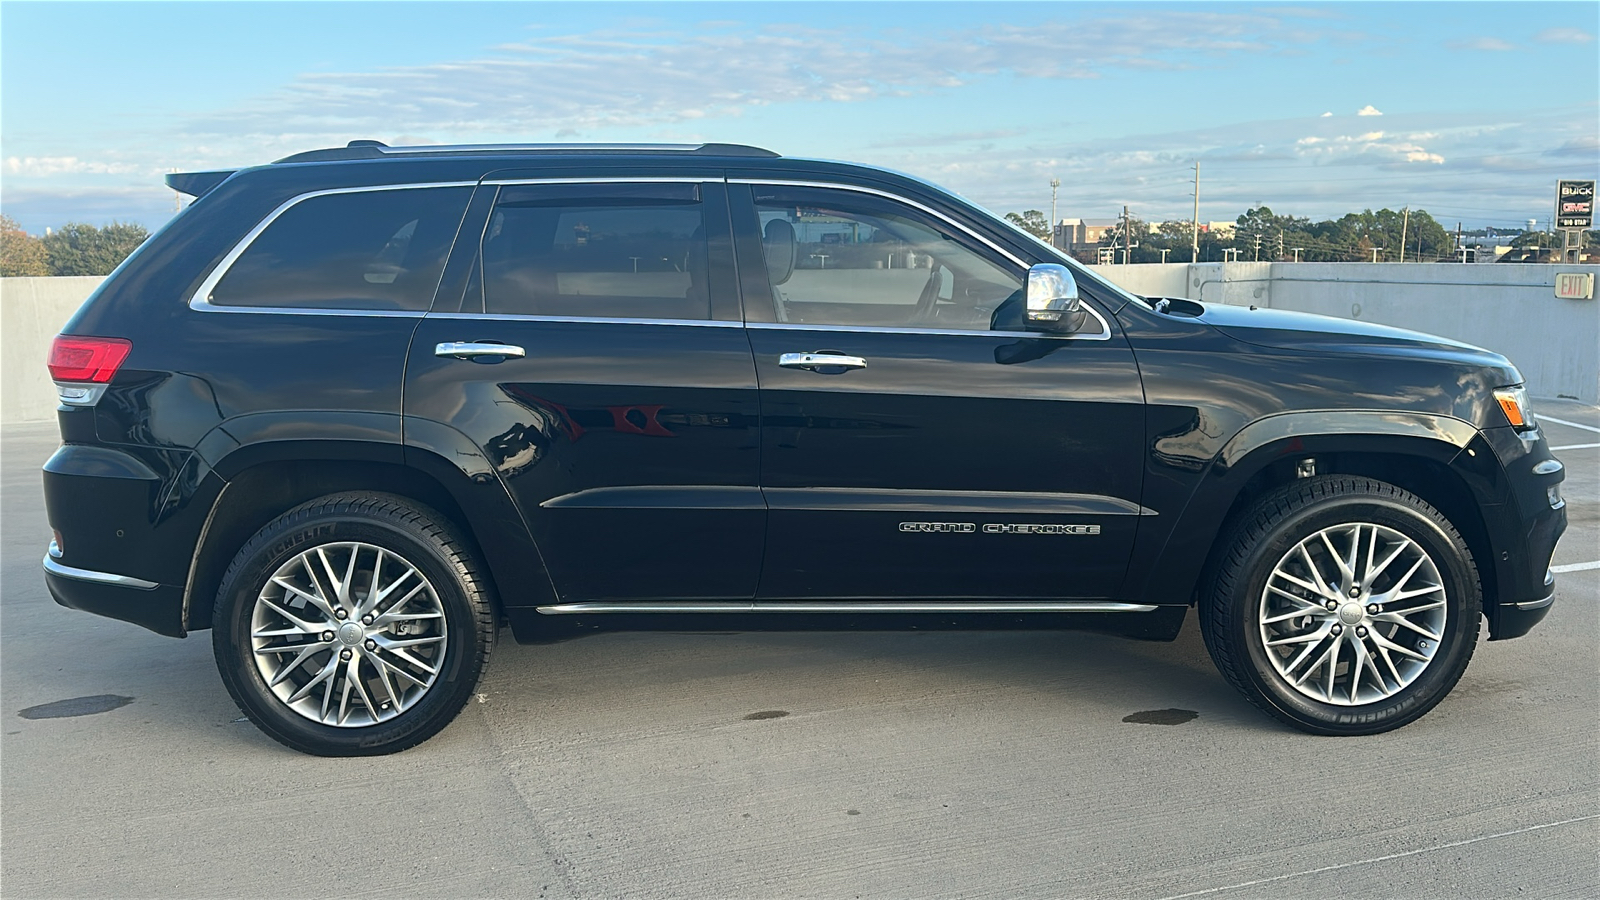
(0, 0, 1600, 234)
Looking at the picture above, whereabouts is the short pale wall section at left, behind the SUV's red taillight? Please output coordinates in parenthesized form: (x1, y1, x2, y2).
(0, 275, 106, 424)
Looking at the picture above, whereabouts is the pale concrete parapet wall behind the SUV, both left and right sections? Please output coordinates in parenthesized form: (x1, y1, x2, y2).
(0, 263, 1600, 424)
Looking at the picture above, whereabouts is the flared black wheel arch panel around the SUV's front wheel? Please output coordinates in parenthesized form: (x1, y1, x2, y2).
(1123, 410, 1472, 604)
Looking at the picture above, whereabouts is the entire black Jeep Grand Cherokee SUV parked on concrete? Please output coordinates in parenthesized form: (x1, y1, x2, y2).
(45, 141, 1566, 754)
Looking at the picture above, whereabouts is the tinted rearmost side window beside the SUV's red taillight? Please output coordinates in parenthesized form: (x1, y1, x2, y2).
(210, 187, 472, 312)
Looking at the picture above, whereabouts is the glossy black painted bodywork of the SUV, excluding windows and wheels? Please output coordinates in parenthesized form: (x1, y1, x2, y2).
(45, 152, 1565, 641)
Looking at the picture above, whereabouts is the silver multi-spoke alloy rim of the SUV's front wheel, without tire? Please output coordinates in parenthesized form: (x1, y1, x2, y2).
(1258, 522, 1448, 706)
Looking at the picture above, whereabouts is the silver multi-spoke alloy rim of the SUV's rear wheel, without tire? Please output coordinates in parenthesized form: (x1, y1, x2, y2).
(250, 543, 446, 729)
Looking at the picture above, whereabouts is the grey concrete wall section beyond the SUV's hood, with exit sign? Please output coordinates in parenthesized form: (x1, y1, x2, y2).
(1094, 263, 1600, 404)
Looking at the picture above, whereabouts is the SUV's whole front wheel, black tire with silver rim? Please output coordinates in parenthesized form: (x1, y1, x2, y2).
(1200, 476, 1483, 735)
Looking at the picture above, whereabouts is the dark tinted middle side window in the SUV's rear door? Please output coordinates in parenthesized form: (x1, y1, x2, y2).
(467, 184, 710, 319)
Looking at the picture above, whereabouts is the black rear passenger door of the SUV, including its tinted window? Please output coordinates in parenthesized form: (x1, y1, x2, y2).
(405, 173, 765, 605)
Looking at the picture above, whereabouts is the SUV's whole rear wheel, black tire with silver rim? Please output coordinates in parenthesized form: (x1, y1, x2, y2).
(211, 492, 496, 756)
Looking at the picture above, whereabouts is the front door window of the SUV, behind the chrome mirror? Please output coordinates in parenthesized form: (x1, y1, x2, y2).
(755, 186, 1022, 331)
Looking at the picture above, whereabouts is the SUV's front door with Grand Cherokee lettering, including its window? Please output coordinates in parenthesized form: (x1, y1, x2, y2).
(731, 184, 1144, 601)
